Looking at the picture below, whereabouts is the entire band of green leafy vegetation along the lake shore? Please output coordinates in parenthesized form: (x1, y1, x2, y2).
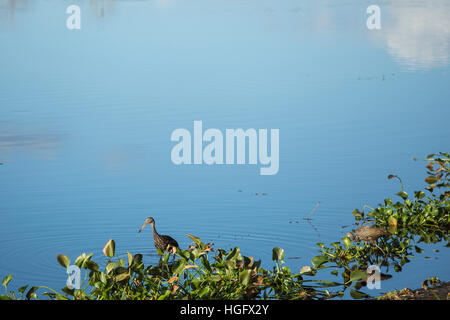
(0, 152, 450, 300)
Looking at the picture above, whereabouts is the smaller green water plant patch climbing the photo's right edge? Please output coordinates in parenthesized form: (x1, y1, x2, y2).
(308, 153, 450, 296)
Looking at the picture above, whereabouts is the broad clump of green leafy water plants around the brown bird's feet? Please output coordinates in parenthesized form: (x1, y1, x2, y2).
(1, 235, 342, 300)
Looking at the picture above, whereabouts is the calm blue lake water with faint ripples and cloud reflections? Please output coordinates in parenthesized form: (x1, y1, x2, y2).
(0, 0, 450, 294)
